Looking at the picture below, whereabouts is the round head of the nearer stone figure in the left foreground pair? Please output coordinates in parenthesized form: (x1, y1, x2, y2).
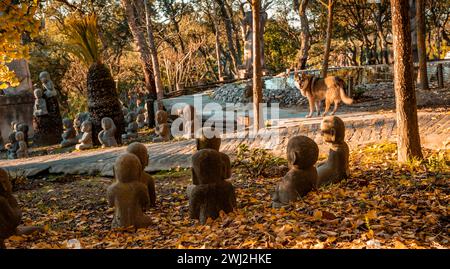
(114, 153, 142, 183)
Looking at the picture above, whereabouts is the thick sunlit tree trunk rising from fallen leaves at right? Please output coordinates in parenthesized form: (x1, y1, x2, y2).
(391, 0, 422, 162)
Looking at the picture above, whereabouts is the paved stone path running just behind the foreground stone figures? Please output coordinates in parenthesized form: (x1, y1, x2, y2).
(0, 112, 450, 177)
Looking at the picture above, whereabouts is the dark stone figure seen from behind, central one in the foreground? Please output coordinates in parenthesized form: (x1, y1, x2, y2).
(187, 149, 236, 224)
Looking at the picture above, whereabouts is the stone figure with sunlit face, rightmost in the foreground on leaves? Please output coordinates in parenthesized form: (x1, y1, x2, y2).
(317, 116, 350, 185)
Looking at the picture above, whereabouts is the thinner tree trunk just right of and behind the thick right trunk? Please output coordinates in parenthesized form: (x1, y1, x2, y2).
(416, 0, 430, 90)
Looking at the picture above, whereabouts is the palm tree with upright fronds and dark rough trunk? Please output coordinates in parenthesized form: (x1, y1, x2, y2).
(64, 14, 124, 145)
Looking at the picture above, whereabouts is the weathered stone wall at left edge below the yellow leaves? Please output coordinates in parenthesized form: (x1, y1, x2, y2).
(0, 93, 34, 143)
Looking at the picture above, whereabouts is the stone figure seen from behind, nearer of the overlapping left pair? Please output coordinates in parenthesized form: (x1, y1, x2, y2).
(107, 153, 151, 229)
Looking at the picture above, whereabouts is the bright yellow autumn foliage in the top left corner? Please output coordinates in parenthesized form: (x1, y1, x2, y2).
(0, 0, 39, 90)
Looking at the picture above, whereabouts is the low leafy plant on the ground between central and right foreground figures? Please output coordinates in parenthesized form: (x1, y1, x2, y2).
(233, 144, 286, 178)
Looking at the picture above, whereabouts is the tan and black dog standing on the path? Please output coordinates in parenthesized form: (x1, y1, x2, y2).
(294, 73, 353, 118)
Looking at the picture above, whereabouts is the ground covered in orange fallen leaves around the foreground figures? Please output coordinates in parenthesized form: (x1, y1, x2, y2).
(6, 143, 450, 248)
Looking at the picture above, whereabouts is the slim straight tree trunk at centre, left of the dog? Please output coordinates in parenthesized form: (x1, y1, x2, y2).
(252, 0, 262, 132)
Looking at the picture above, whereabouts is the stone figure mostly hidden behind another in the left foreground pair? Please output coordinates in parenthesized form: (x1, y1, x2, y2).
(127, 142, 156, 206)
